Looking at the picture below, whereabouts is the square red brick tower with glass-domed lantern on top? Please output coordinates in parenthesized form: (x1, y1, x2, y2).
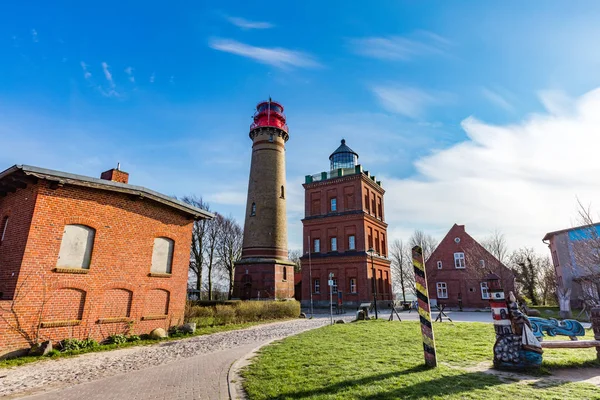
(301, 139, 392, 307)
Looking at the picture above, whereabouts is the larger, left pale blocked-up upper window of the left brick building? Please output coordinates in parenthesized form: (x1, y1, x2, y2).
(56, 225, 96, 269)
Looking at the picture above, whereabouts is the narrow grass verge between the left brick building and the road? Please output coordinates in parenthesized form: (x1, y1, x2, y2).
(0, 319, 285, 369)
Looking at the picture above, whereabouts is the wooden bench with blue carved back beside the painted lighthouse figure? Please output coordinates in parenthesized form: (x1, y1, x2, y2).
(529, 309, 600, 359)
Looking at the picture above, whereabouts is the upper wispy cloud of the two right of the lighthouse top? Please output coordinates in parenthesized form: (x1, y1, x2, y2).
(350, 31, 451, 61)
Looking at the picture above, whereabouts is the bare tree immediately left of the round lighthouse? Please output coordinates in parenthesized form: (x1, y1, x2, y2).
(216, 216, 244, 299)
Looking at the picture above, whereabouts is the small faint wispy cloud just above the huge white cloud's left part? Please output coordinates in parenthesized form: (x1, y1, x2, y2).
(371, 85, 452, 119)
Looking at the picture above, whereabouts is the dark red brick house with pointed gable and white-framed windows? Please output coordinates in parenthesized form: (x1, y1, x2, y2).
(425, 224, 515, 308)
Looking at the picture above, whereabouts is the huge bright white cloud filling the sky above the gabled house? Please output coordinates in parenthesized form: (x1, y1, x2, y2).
(382, 89, 600, 252)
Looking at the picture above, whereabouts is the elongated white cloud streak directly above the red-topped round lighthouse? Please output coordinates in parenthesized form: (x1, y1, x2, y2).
(209, 38, 319, 68)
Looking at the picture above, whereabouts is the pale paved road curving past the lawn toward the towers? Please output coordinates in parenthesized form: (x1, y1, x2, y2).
(7, 311, 491, 400)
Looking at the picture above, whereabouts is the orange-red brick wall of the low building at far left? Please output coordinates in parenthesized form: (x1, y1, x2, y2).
(0, 181, 192, 354)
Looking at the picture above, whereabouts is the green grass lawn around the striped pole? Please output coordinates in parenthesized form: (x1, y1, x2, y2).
(242, 321, 600, 400)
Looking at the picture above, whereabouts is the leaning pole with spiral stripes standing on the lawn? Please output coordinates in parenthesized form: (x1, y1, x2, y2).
(412, 246, 437, 367)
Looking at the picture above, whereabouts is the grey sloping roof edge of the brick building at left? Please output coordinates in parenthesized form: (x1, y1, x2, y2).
(0, 165, 214, 219)
